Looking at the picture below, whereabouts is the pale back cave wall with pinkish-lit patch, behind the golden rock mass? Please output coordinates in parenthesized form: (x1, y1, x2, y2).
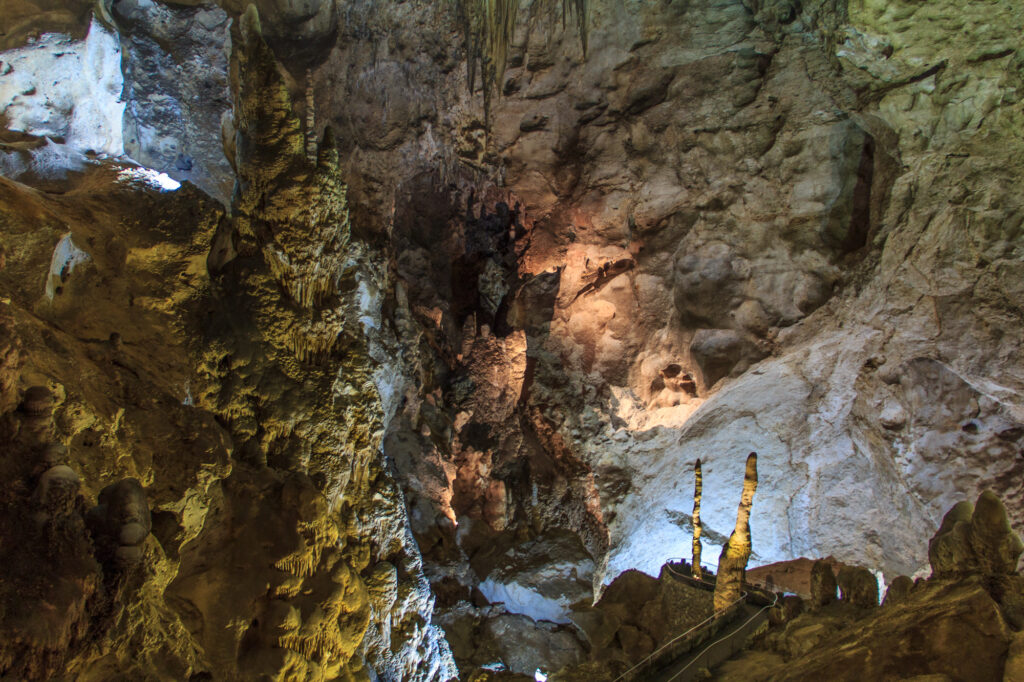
(3, 0, 1020, 593)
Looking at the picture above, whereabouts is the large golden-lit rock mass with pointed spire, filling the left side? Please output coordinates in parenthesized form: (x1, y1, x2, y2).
(0, 5, 455, 680)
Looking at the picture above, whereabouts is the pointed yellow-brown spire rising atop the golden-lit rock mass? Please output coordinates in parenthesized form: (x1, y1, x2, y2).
(232, 7, 350, 308)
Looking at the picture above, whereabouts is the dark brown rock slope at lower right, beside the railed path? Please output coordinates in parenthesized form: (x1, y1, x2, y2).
(714, 496, 1024, 682)
